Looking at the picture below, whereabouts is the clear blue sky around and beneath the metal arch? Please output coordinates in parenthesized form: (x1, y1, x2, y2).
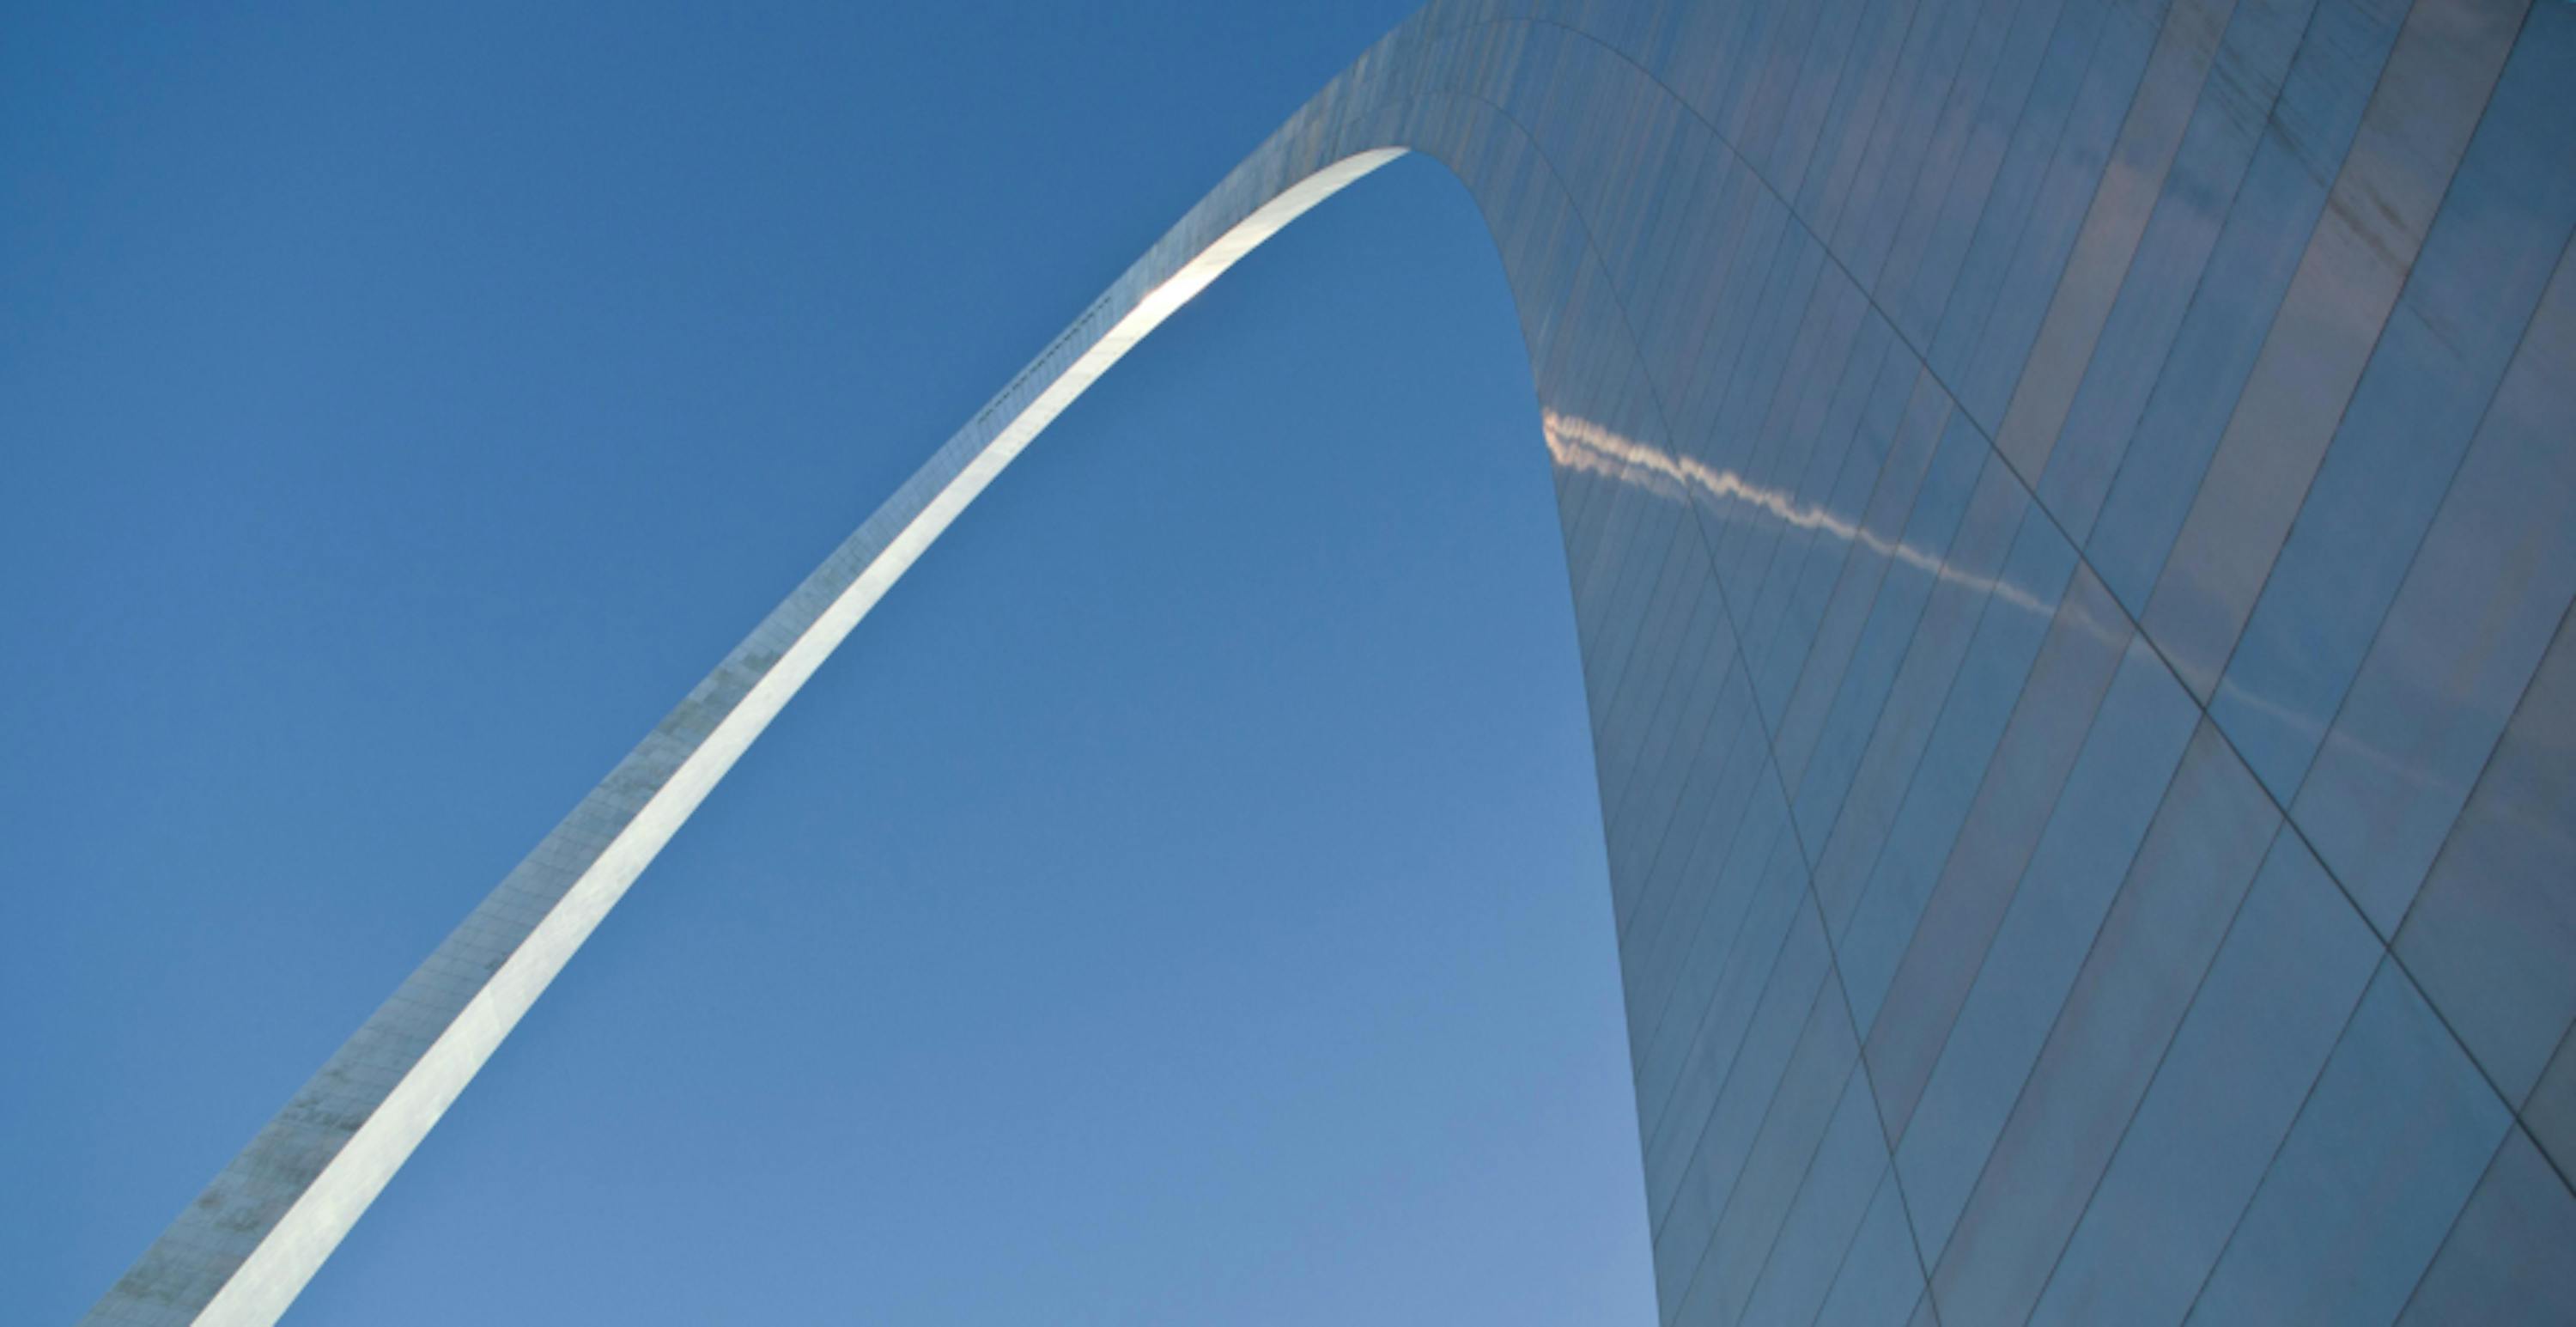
(0, 0, 1651, 1324)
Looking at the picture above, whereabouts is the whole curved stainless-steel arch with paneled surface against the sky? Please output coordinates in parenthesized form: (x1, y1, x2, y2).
(90, 0, 2576, 1327)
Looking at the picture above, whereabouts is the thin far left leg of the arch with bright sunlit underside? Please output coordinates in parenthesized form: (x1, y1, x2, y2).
(82, 13, 1525, 1324)
